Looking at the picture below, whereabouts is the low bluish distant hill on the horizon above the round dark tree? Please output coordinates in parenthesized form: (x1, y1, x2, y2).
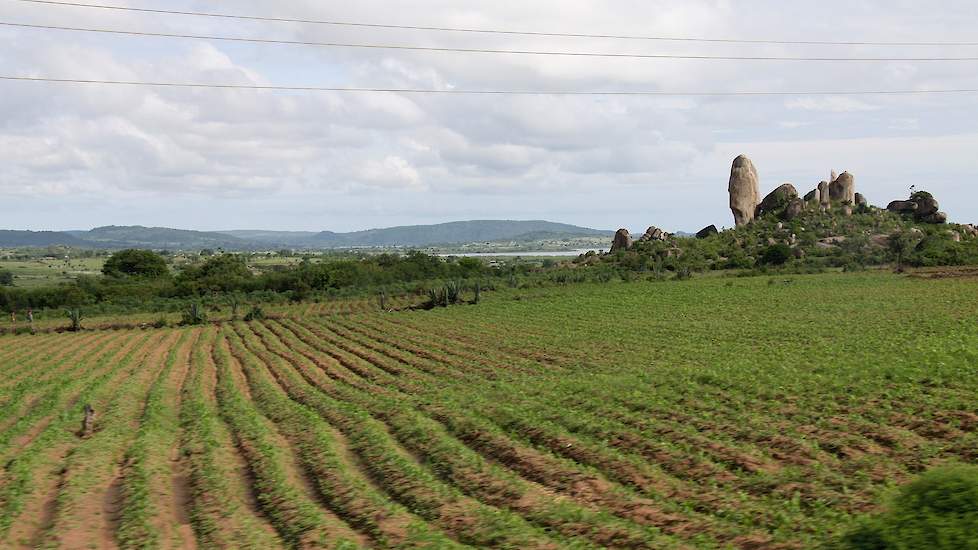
(74, 225, 263, 250)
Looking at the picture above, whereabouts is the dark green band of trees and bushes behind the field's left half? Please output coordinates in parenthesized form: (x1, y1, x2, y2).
(0, 250, 488, 311)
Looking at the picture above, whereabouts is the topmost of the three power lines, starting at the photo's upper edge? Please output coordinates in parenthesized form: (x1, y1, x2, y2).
(9, 0, 978, 46)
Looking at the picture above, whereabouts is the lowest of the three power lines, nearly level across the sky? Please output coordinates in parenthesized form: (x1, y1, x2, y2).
(0, 75, 978, 97)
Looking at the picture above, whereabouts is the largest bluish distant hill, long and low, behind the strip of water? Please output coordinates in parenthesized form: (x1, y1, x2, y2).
(309, 220, 614, 248)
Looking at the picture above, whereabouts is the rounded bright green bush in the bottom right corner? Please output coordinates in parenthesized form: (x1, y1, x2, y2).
(842, 466, 978, 550)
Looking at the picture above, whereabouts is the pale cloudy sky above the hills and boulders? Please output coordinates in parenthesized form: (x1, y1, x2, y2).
(0, 0, 978, 233)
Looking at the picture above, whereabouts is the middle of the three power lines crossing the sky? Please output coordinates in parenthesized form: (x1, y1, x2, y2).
(0, 21, 978, 62)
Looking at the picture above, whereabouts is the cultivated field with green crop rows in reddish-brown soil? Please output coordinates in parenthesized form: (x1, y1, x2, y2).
(0, 274, 978, 548)
